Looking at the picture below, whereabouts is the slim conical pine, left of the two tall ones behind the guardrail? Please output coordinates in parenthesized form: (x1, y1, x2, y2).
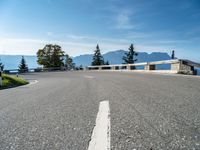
(91, 44, 104, 66)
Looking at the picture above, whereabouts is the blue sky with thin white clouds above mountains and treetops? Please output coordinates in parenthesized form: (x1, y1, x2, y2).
(0, 0, 200, 62)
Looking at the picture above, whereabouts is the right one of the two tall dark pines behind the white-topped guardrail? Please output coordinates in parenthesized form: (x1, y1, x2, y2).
(123, 44, 138, 64)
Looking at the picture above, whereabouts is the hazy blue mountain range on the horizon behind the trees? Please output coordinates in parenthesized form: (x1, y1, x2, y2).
(0, 50, 170, 69)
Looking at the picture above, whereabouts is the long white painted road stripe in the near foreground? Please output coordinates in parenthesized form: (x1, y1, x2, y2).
(88, 101, 111, 150)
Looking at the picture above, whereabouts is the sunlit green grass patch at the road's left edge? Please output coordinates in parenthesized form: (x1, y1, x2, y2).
(0, 74, 28, 89)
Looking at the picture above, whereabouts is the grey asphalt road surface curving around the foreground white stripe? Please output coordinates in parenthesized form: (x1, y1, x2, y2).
(0, 71, 200, 150)
